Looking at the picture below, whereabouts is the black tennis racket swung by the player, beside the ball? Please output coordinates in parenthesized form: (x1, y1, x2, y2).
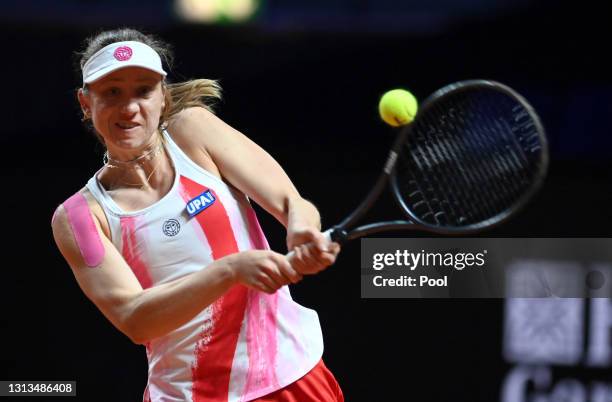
(288, 80, 548, 259)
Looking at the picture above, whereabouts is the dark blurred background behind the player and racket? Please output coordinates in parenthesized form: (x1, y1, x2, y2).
(0, 0, 612, 402)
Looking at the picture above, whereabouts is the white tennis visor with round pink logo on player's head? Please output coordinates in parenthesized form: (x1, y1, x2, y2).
(83, 41, 167, 85)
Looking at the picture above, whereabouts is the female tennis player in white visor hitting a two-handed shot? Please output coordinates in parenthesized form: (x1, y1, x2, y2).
(52, 29, 343, 402)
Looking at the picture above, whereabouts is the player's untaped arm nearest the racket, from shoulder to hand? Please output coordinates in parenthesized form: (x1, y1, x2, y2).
(169, 107, 337, 272)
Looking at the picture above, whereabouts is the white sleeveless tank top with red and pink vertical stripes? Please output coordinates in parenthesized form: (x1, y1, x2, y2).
(87, 132, 323, 402)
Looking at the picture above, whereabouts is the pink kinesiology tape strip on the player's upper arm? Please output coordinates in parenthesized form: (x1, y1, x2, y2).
(64, 193, 104, 267)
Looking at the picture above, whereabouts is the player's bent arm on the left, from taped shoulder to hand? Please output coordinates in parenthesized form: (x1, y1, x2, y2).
(52, 193, 301, 344)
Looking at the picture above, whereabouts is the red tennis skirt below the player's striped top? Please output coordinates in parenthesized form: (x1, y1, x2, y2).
(253, 360, 344, 402)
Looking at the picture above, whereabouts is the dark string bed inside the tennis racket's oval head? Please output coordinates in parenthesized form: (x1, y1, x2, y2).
(396, 90, 541, 226)
